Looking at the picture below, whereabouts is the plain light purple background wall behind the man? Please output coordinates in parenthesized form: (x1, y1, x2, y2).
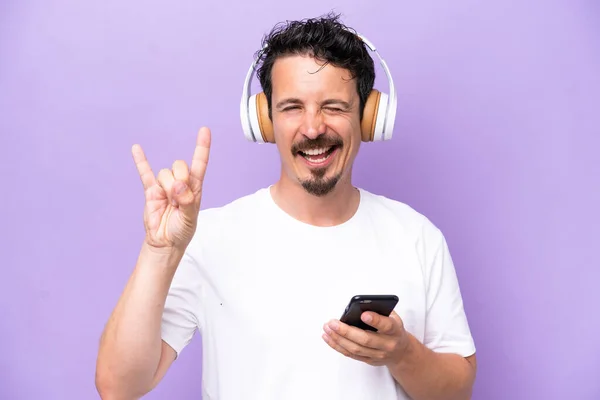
(0, 0, 600, 400)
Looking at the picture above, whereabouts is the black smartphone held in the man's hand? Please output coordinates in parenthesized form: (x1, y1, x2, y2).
(340, 294, 398, 332)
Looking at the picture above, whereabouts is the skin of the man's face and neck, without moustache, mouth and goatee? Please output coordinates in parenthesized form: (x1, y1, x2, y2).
(271, 55, 361, 226)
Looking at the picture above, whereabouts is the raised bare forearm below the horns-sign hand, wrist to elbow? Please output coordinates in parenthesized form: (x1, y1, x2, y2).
(96, 245, 182, 399)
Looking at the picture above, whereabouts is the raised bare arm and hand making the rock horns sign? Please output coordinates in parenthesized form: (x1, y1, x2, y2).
(95, 128, 211, 400)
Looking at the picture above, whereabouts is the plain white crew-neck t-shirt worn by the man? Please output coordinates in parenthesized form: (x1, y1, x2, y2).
(162, 188, 475, 400)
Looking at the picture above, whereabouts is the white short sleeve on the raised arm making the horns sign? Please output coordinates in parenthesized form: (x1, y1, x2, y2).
(161, 247, 202, 356)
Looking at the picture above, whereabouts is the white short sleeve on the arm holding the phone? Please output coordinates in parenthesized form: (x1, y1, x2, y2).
(421, 226, 475, 357)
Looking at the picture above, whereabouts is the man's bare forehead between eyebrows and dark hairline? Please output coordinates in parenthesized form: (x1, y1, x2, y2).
(271, 55, 357, 100)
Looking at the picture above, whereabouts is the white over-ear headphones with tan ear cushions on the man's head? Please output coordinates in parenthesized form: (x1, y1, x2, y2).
(240, 33, 398, 143)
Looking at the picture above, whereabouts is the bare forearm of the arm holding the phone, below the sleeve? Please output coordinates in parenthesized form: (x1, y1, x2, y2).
(389, 334, 475, 400)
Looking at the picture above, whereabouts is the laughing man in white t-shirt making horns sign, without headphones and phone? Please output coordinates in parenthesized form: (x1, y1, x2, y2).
(96, 15, 476, 400)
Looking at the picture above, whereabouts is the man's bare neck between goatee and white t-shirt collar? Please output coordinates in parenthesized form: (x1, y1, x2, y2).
(271, 176, 360, 226)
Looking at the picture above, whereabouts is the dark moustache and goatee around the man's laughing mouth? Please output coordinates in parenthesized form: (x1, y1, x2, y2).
(291, 135, 343, 197)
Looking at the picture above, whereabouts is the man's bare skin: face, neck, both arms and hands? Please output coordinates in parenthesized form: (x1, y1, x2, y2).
(96, 56, 476, 400)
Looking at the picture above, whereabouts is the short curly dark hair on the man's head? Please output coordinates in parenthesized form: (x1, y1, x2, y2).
(256, 13, 375, 120)
